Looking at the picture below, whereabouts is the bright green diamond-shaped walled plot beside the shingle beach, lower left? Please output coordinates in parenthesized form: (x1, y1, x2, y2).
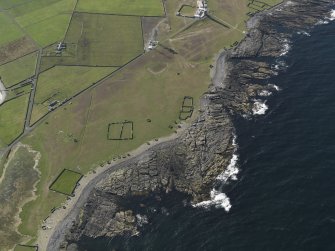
(49, 169, 83, 195)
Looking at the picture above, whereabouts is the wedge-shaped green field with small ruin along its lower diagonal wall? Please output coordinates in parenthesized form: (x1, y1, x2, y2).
(30, 66, 117, 124)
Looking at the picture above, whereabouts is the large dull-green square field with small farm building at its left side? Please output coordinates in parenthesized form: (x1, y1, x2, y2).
(41, 13, 144, 71)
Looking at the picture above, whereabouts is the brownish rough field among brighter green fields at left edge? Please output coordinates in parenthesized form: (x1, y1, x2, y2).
(0, 36, 37, 65)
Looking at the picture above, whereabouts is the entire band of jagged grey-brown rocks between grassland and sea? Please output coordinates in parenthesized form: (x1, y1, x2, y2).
(48, 0, 334, 250)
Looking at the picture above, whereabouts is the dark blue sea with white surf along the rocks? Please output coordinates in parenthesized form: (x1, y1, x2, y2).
(79, 19, 335, 251)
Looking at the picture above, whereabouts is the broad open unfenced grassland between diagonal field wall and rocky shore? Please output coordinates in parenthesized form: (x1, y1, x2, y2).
(20, 42, 211, 240)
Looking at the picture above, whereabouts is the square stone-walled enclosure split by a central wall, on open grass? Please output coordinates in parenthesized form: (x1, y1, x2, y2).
(107, 121, 133, 140)
